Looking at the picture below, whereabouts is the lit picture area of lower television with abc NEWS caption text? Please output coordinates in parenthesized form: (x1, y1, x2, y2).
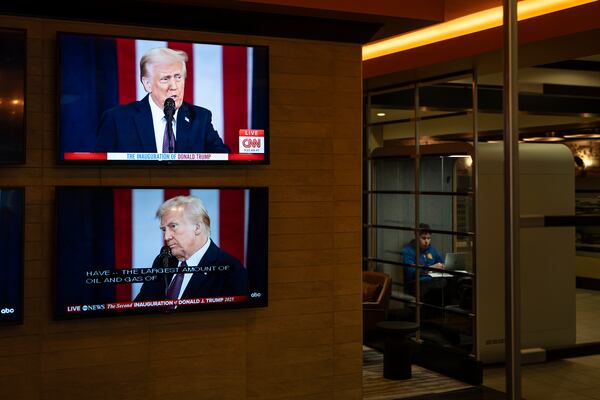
(54, 187, 268, 319)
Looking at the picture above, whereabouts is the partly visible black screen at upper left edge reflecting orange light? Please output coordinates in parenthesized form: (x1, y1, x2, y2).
(0, 28, 26, 164)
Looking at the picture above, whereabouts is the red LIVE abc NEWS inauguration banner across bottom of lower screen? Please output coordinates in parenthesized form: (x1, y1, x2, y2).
(67, 296, 248, 313)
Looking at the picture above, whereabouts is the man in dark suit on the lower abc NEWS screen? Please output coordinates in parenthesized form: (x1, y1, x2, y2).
(135, 196, 248, 301)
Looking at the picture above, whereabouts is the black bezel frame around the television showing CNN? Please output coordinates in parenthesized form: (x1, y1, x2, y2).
(55, 31, 271, 168)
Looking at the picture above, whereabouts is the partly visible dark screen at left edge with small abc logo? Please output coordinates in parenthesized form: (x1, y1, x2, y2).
(0, 188, 24, 324)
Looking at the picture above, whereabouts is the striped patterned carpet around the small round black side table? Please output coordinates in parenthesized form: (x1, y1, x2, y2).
(363, 346, 472, 400)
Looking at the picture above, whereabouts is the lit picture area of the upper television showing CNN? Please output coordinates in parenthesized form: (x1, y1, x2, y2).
(58, 33, 269, 164)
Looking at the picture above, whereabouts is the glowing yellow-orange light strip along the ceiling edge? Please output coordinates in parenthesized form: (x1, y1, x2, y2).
(363, 0, 597, 61)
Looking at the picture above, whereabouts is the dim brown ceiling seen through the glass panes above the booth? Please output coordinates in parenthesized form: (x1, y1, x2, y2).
(369, 55, 600, 141)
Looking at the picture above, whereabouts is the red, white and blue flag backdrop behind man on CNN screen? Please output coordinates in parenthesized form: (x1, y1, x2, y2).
(58, 33, 268, 154)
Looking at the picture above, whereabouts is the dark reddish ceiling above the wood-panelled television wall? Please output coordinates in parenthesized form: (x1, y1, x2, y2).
(0, 0, 501, 44)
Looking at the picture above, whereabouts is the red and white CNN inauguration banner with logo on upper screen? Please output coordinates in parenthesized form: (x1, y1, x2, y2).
(64, 129, 265, 162)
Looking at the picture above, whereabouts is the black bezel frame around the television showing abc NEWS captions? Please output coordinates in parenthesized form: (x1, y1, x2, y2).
(50, 185, 269, 321)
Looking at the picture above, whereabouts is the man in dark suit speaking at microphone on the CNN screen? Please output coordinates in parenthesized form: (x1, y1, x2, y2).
(95, 47, 229, 153)
